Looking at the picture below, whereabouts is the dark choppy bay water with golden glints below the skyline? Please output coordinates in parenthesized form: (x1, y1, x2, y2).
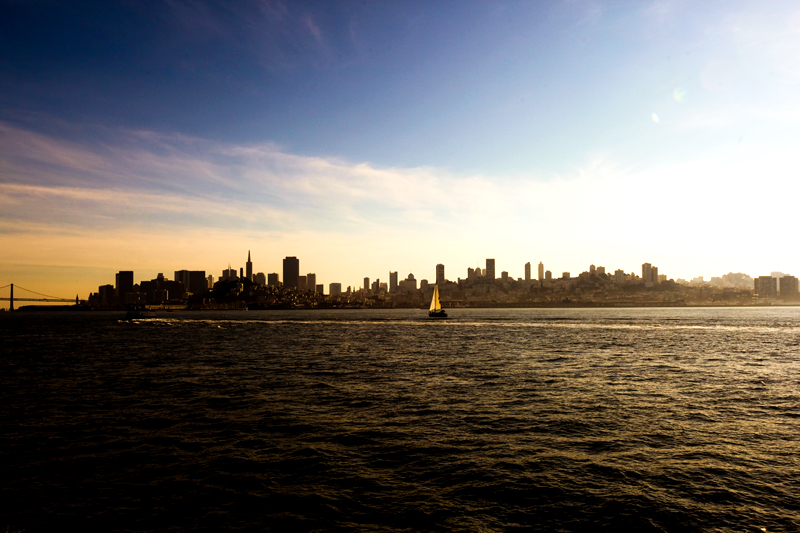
(0, 308, 800, 532)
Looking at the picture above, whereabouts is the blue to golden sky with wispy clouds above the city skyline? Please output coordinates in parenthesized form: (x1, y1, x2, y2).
(0, 0, 800, 298)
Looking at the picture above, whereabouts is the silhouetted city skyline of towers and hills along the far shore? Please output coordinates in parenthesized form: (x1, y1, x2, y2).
(88, 252, 800, 309)
